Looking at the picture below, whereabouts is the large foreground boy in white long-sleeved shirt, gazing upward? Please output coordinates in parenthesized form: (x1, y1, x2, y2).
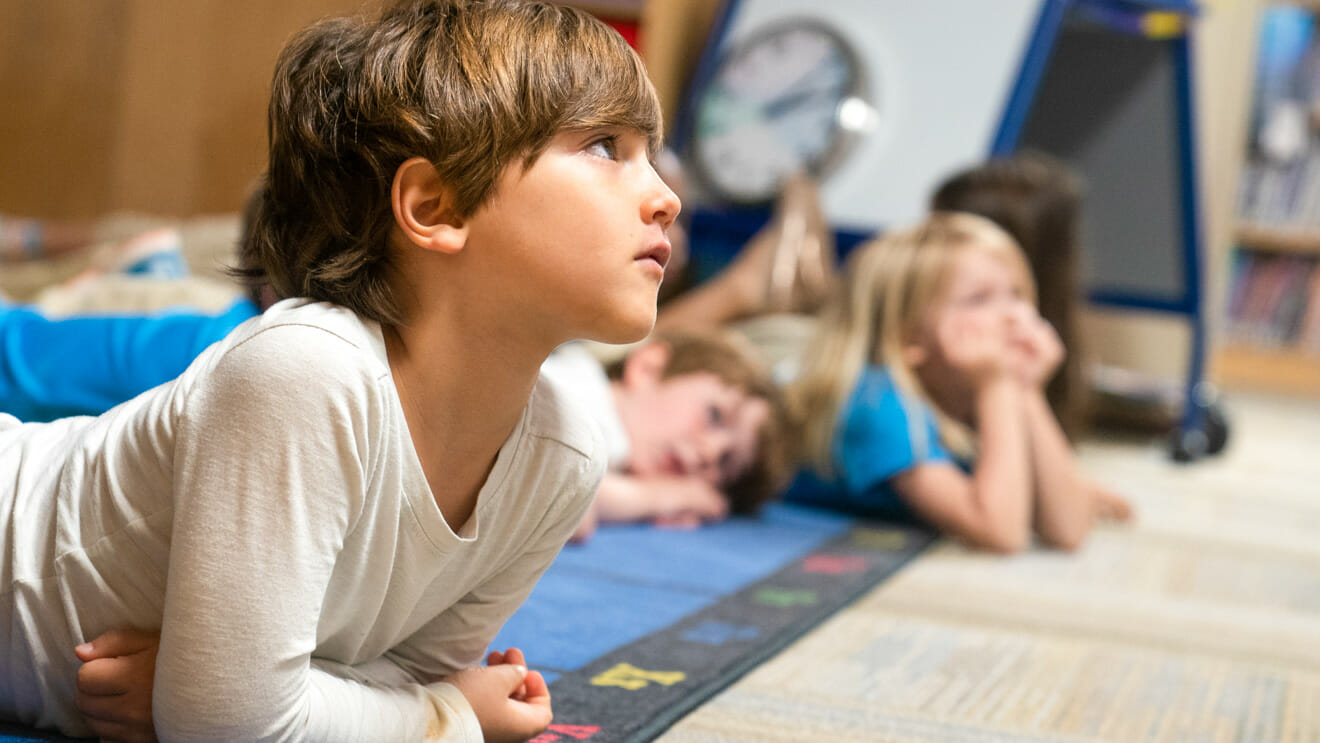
(0, 0, 680, 742)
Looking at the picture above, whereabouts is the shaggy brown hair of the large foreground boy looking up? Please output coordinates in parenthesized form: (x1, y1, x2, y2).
(238, 0, 661, 323)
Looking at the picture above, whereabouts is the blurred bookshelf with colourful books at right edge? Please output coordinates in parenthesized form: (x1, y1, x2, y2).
(1213, 0, 1320, 396)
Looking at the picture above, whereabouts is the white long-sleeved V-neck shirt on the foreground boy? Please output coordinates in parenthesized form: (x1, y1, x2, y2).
(0, 301, 605, 742)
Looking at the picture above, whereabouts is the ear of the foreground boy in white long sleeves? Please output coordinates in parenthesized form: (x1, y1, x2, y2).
(389, 157, 467, 253)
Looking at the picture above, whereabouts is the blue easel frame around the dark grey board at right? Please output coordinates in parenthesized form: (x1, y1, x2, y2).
(990, 0, 1208, 453)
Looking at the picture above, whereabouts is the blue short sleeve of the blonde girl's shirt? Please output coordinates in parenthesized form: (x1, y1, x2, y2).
(834, 370, 953, 496)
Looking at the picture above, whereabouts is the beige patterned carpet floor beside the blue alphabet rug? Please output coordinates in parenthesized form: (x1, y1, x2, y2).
(660, 393, 1320, 743)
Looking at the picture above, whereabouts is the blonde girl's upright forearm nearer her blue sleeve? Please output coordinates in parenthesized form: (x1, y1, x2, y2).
(973, 376, 1032, 552)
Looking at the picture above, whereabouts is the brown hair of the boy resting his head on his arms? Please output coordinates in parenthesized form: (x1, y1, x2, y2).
(606, 330, 792, 513)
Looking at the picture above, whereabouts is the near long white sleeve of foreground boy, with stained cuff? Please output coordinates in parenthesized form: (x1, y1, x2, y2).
(153, 326, 480, 742)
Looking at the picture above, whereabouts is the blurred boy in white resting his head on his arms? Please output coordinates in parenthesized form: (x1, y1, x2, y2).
(541, 330, 789, 541)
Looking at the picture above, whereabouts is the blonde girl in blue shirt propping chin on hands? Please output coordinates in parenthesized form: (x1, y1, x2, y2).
(788, 212, 1119, 553)
